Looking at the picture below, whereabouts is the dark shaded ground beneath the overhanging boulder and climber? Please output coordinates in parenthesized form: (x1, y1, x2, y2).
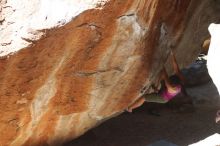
(66, 104, 220, 146)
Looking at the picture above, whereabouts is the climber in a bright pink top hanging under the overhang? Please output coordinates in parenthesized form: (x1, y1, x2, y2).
(127, 51, 186, 112)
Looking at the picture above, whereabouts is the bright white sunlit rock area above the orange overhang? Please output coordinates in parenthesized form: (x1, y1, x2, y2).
(0, 0, 107, 56)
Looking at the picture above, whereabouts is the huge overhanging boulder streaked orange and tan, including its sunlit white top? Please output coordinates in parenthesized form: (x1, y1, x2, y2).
(0, 0, 220, 146)
